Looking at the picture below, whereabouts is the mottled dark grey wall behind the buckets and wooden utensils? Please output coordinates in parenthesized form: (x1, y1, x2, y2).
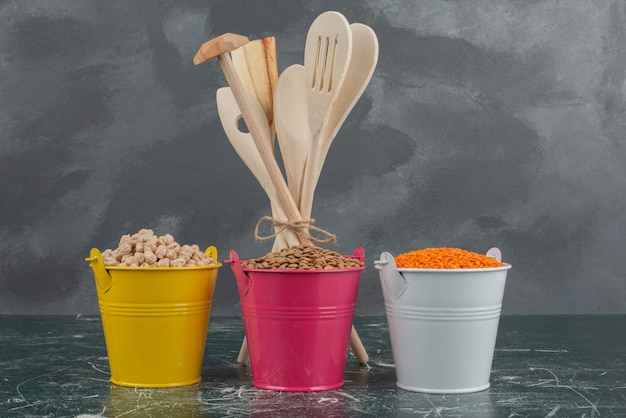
(0, 0, 626, 315)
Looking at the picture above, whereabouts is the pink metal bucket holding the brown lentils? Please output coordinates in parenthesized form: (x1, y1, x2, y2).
(227, 247, 364, 392)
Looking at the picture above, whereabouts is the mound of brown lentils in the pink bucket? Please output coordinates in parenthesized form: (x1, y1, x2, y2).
(242, 245, 364, 270)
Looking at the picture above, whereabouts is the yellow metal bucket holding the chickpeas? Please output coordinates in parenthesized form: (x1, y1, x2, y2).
(86, 246, 222, 388)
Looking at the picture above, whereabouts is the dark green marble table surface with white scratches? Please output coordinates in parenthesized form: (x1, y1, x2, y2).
(0, 315, 626, 417)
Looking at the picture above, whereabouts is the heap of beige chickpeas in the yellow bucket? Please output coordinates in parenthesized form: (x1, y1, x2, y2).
(102, 229, 218, 267)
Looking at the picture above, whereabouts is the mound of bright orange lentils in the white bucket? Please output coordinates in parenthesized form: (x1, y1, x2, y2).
(394, 247, 505, 269)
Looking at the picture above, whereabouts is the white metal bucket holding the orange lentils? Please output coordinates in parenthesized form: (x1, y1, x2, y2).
(374, 251, 511, 393)
